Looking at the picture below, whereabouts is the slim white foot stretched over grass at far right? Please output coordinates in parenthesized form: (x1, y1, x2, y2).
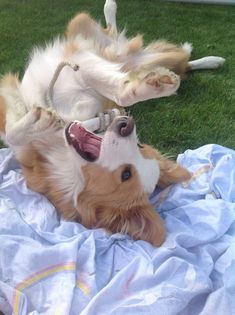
(188, 56, 225, 70)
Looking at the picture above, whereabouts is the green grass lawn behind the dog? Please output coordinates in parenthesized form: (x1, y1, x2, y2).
(0, 0, 235, 155)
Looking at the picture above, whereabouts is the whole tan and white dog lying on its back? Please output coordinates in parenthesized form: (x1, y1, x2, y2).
(0, 0, 222, 246)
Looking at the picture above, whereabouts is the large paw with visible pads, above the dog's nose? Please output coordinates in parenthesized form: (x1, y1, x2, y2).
(121, 67, 180, 106)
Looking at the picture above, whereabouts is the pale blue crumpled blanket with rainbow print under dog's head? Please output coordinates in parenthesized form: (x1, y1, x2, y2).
(0, 145, 235, 315)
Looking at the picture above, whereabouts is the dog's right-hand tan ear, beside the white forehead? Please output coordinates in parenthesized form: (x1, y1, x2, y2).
(140, 144, 192, 188)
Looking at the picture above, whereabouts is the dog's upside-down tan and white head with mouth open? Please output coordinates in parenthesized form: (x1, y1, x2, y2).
(65, 117, 190, 246)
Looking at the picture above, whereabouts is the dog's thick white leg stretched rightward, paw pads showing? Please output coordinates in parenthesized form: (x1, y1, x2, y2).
(74, 52, 180, 106)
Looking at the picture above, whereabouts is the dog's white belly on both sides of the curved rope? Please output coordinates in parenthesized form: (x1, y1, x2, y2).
(20, 47, 104, 121)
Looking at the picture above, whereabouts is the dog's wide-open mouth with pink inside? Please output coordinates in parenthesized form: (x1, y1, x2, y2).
(65, 122, 102, 162)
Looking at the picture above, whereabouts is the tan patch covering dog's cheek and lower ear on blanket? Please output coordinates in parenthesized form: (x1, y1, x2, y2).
(78, 165, 165, 246)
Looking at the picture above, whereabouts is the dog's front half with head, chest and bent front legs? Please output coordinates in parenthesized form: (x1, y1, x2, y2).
(0, 76, 190, 246)
